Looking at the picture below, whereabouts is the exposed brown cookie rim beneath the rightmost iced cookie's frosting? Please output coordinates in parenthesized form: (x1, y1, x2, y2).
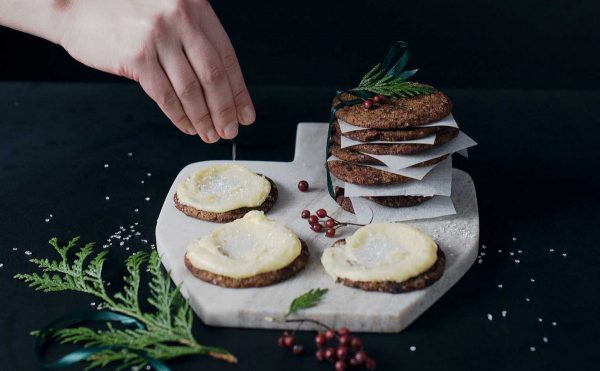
(333, 239, 446, 294)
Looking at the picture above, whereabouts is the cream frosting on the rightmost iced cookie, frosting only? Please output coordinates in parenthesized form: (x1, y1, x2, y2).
(321, 223, 437, 282)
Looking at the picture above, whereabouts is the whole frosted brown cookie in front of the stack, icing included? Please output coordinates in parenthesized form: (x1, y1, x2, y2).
(321, 223, 446, 293)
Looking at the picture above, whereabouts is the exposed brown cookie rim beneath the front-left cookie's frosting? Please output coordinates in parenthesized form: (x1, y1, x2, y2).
(184, 240, 310, 289)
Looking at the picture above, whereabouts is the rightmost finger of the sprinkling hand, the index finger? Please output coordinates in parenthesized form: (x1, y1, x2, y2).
(196, 2, 256, 125)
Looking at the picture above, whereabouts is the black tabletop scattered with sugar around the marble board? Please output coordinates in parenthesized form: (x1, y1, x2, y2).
(0, 83, 600, 370)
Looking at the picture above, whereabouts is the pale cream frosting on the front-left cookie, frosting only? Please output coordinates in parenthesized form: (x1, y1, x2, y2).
(186, 210, 302, 278)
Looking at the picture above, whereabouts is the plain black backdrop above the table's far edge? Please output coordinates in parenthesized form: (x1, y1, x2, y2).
(0, 0, 600, 89)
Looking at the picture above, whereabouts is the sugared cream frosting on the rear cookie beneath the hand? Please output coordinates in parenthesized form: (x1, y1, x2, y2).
(177, 164, 271, 213)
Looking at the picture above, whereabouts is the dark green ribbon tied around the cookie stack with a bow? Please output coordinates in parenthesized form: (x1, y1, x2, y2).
(325, 41, 418, 200)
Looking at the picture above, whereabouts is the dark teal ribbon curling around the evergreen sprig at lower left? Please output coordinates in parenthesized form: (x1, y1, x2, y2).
(35, 310, 170, 371)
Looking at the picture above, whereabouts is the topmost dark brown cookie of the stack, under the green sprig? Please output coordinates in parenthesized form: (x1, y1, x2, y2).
(333, 83, 452, 130)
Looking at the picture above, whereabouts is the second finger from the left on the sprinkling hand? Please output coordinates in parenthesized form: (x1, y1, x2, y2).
(159, 42, 219, 143)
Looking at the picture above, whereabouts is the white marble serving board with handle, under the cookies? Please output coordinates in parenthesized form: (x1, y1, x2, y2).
(156, 123, 479, 332)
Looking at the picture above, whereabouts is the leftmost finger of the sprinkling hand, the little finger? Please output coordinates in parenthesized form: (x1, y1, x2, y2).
(140, 58, 196, 135)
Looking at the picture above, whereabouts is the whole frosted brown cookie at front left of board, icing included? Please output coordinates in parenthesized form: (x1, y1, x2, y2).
(184, 211, 309, 288)
